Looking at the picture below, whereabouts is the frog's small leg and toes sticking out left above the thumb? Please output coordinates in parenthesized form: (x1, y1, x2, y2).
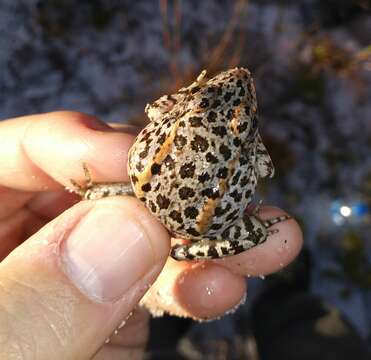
(70, 163, 134, 200)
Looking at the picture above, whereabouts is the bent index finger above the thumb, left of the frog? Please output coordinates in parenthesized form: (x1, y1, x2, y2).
(0, 111, 134, 191)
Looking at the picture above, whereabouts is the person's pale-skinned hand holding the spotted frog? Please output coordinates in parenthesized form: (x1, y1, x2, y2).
(0, 111, 302, 359)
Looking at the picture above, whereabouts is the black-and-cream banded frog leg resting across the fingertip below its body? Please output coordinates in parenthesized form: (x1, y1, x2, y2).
(171, 214, 291, 260)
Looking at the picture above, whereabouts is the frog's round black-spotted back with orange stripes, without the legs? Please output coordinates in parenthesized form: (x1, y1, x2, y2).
(129, 69, 264, 239)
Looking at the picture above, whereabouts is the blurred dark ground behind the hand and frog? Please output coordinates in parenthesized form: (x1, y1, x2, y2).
(0, 0, 371, 360)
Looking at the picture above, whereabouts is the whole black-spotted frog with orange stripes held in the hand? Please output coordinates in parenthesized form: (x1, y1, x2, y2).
(75, 68, 289, 260)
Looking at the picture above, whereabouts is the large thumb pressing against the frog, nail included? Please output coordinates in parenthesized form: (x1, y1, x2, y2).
(0, 197, 170, 359)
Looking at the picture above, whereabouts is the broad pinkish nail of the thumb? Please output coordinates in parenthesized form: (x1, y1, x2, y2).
(62, 207, 156, 302)
